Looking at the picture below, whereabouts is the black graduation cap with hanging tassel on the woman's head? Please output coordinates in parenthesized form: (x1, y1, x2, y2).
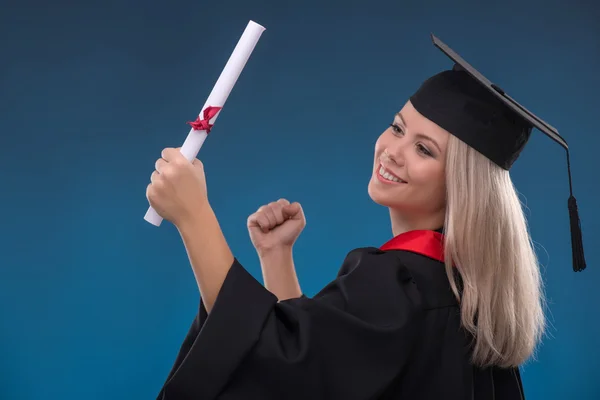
(410, 34, 586, 272)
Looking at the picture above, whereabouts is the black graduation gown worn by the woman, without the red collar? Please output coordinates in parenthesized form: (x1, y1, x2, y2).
(157, 247, 524, 400)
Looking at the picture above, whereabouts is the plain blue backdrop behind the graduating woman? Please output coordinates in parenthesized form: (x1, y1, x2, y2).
(0, 0, 600, 400)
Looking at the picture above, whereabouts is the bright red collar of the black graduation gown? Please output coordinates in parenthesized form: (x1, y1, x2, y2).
(380, 230, 444, 262)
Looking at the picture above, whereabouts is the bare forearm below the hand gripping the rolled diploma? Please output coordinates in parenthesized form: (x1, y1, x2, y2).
(177, 204, 234, 313)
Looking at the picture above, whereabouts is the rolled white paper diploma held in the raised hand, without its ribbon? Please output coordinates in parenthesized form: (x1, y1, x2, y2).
(144, 21, 265, 226)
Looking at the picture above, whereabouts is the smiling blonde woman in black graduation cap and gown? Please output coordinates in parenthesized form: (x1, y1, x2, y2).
(147, 38, 583, 400)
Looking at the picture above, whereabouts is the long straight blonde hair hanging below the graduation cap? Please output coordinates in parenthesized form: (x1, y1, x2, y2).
(444, 135, 545, 367)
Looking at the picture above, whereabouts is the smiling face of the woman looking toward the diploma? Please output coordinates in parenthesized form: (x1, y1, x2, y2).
(369, 101, 450, 218)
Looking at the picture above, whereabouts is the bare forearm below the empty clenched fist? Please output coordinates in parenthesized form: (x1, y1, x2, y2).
(259, 247, 302, 301)
